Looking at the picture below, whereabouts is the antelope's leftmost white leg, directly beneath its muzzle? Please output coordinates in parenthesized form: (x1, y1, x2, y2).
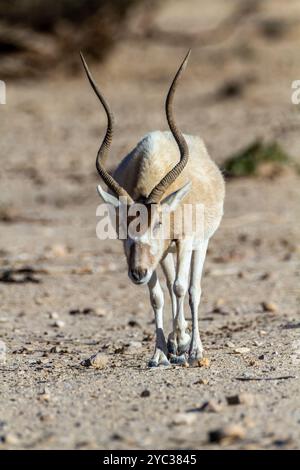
(148, 271, 170, 367)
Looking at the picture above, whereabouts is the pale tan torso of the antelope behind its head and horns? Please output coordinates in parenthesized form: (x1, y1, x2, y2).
(114, 131, 225, 239)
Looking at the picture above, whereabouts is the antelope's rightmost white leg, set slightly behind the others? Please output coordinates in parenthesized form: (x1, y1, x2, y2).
(189, 240, 208, 365)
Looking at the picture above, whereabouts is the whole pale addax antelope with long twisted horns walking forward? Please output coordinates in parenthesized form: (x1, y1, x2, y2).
(81, 53, 225, 367)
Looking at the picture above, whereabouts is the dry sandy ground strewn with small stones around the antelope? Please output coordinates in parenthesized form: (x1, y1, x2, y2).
(0, 0, 300, 449)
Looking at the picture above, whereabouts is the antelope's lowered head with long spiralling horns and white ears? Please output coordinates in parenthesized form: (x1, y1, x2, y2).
(80, 51, 191, 284)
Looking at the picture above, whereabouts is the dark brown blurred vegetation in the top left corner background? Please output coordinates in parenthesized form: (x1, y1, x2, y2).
(0, 0, 157, 78)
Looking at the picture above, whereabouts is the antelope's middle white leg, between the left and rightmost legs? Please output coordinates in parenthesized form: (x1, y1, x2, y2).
(168, 239, 192, 364)
